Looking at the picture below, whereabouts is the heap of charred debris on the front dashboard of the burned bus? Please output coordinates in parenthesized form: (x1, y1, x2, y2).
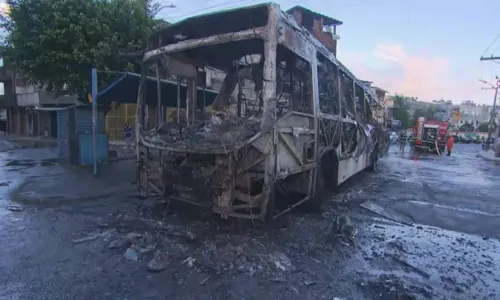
(144, 112, 260, 151)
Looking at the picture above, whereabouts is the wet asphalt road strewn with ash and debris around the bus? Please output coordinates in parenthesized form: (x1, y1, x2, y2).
(0, 141, 500, 300)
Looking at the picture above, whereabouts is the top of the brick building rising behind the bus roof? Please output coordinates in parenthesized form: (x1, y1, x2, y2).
(287, 6, 342, 56)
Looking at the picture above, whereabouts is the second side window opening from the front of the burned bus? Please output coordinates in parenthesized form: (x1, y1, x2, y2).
(318, 53, 340, 115)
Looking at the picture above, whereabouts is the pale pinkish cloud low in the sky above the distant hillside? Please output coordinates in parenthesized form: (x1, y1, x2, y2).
(339, 44, 479, 102)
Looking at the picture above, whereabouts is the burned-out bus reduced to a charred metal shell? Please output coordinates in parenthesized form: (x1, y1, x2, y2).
(136, 4, 380, 220)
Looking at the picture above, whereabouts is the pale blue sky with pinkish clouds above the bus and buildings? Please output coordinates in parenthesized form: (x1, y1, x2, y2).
(0, 0, 500, 104)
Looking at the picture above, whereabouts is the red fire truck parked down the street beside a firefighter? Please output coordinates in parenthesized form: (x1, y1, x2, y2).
(412, 117, 448, 155)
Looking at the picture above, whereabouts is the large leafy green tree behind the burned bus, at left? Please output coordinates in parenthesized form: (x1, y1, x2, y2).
(0, 0, 156, 99)
